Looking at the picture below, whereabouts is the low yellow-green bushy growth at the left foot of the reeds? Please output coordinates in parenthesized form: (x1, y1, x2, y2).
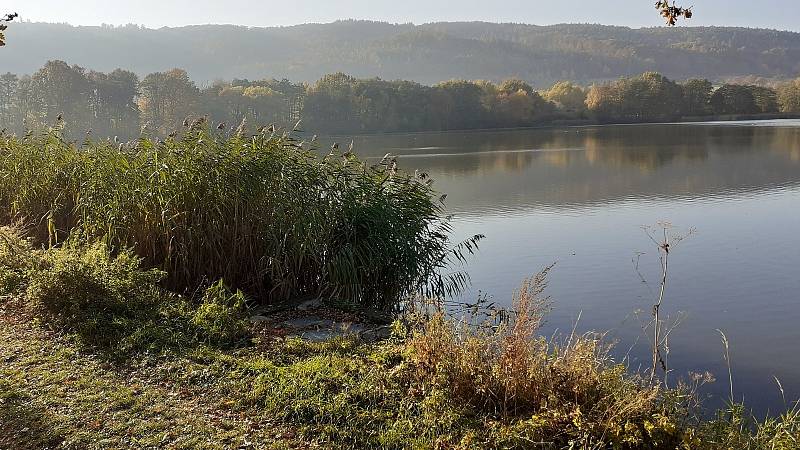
(16, 237, 249, 357)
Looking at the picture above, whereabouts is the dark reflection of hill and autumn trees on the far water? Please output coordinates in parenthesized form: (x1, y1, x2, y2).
(344, 125, 800, 214)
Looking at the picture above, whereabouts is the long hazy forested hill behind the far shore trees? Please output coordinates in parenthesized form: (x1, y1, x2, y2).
(0, 21, 800, 86)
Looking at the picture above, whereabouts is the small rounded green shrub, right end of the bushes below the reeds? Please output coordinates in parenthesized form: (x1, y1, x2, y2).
(192, 280, 249, 346)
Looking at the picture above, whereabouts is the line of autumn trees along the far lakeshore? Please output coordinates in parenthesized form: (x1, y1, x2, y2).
(0, 61, 800, 139)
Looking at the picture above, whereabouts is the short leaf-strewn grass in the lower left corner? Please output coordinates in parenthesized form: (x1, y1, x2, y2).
(0, 317, 304, 450)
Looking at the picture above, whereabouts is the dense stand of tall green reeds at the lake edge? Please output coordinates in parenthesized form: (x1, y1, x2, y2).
(0, 121, 477, 309)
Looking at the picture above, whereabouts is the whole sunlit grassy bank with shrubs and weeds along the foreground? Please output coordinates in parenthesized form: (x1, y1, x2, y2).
(0, 229, 800, 449)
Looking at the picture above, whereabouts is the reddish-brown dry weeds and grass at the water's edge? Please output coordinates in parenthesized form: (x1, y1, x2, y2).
(408, 272, 684, 448)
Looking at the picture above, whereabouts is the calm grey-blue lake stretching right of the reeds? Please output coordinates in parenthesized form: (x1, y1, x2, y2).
(345, 120, 800, 412)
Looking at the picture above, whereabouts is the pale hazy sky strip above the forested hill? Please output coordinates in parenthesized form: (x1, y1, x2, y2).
(6, 0, 800, 31)
